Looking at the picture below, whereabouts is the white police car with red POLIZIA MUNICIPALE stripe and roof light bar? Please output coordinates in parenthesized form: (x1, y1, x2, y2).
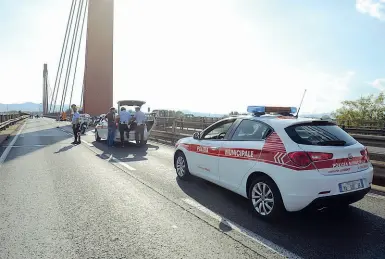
(174, 106, 373, 218)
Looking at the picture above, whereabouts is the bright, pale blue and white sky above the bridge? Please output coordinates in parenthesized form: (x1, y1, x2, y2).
(0, 0, 385, 113)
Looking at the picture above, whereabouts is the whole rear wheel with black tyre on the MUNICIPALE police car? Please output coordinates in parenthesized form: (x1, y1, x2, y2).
(248, 176, 286, 220)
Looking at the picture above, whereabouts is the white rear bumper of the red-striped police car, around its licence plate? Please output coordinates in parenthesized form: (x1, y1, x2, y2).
(280, 166, 373, 211)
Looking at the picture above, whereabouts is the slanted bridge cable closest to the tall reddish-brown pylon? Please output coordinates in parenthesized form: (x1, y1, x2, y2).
(60, 0, 84, 112)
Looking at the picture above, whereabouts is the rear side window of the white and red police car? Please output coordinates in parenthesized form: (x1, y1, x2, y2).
(231, 120, 272, 141)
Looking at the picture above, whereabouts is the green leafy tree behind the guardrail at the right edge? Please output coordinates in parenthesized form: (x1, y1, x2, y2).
(332, 92, 385, 124)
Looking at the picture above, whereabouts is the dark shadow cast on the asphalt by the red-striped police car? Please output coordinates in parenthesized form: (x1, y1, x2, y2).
(177, 177, 385, 258)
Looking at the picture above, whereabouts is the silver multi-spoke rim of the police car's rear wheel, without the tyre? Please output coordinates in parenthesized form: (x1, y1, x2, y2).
(251, 182, 274, 216)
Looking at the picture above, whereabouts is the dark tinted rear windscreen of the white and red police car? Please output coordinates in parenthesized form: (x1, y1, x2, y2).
(285, 121, 357, 146)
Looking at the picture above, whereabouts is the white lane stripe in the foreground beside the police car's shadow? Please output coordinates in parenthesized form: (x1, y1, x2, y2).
(182, 198, 302, 259)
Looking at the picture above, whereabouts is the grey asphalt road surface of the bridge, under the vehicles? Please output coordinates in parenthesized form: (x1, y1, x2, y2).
(0, 119, 385, 258)
